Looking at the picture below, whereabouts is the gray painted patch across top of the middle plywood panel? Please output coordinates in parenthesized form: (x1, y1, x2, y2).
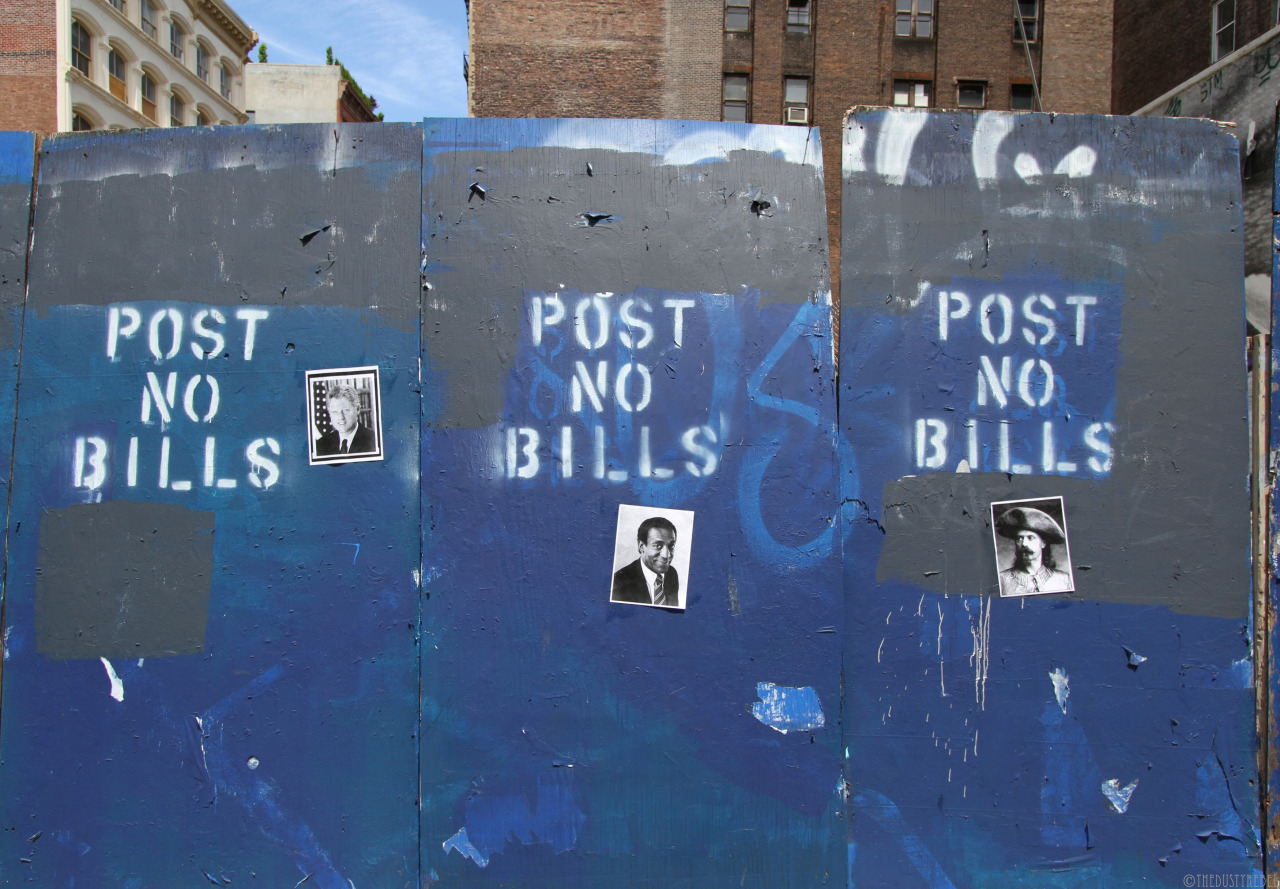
(422, 122, 829, 427)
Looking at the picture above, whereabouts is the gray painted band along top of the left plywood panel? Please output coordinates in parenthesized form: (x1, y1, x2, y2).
(32, 124, 422, 330)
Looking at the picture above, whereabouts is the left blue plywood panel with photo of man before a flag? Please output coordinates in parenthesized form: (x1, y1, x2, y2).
(0, 125, 421, 888)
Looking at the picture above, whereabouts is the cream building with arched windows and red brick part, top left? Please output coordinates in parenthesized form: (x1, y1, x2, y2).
(0, 0, 257, 133)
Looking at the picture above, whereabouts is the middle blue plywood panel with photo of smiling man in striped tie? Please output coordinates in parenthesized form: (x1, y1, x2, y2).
(422, 120, 844, 886)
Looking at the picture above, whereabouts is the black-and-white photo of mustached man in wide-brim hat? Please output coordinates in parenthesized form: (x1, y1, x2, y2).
(991, 498, 1075, 596)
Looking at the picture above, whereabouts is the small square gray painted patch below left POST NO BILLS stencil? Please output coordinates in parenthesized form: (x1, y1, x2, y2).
(36, 500, 214, 660)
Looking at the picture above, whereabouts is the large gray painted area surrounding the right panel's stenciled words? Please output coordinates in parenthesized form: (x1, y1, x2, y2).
(841, 115, 1249, 618)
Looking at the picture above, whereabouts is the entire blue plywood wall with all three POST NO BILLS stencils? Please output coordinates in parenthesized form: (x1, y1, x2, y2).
(0, 111, 1261, 889)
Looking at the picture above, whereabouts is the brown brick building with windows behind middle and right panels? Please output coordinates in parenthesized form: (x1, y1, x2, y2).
(468, 0, 1121, 286)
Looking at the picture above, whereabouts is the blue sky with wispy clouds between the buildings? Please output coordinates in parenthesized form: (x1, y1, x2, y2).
(229, 0, 467, 120)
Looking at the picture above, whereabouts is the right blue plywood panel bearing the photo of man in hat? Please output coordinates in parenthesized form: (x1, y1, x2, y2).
(841, 111, 1261, 886)
